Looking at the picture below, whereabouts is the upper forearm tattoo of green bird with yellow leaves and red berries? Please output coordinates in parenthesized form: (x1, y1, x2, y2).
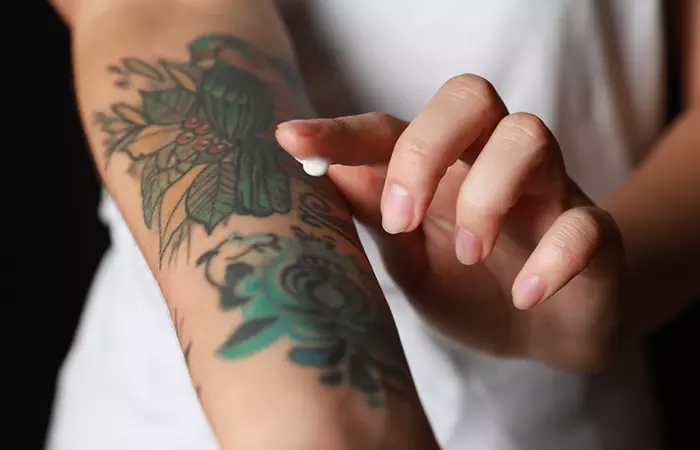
(94, 34, 309, 260)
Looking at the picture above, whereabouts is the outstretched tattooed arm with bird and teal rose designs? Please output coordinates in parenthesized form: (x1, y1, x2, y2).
(57, 0, 435, 450)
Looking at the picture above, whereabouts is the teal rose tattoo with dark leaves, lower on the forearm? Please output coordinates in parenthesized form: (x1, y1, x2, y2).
(197, 227, 407, 407)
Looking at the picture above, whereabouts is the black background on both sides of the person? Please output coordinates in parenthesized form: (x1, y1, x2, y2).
(24, 2, 700, 450)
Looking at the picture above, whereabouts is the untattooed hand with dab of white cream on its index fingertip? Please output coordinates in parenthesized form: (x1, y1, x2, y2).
(277, 75, 623, 371)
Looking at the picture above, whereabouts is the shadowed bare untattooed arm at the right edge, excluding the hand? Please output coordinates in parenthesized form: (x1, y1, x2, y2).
(605, 1, 700, 336)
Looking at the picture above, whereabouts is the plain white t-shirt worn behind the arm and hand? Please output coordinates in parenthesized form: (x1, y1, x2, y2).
(49, 0, 664, 450)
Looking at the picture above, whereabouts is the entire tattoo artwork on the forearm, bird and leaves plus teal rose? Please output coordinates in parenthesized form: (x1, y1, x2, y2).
(95, 35, 404, 407)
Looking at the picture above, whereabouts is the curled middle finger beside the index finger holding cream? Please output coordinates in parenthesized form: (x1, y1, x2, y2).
(382, 74, 507, 233)
